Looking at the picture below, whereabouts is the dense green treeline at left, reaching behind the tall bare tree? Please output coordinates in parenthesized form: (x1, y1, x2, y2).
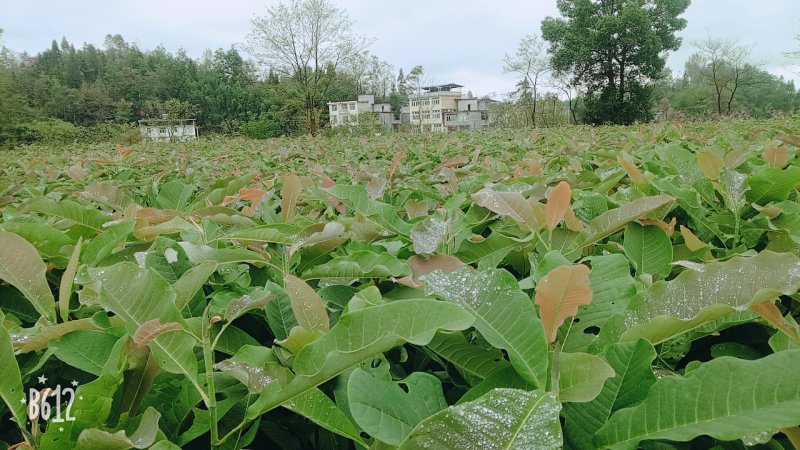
(0, 30, 401, 145)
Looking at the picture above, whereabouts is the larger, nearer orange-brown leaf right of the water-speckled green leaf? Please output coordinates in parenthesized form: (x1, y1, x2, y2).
(534, 264, 592, 342)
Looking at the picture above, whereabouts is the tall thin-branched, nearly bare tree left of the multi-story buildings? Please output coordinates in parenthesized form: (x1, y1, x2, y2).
(246, 0, 372, 133)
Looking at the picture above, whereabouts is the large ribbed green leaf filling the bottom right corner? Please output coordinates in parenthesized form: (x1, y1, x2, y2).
(595, 350, 800, 448)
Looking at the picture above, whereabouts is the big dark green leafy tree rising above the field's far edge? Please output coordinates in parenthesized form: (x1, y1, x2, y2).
(542, 0, 689, 124)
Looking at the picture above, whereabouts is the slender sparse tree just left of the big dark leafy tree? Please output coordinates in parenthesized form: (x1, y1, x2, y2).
(503, 35, 550, 127)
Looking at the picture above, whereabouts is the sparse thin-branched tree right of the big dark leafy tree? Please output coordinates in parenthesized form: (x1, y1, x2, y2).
(694, 36, 763, 116)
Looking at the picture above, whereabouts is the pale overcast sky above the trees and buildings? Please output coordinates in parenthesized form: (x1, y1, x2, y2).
(0, 0, 800, 97)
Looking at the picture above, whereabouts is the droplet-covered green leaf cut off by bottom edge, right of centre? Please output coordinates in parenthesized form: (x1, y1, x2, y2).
(399, 389, 561, 450)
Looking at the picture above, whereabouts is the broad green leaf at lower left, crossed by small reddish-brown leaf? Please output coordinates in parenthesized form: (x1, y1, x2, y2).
(89, 263, 202, 398)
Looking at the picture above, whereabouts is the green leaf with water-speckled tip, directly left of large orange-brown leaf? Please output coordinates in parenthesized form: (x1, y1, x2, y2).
(425, 269, 549, 387)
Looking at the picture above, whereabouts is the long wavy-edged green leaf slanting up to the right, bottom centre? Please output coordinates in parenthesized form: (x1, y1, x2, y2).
(247, 299, 475, 418)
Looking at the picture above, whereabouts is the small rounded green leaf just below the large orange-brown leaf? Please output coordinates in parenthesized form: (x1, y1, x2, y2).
(558, 353, 614, 403)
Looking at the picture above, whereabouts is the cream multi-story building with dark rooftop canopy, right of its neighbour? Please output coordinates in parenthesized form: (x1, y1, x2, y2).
(408, 83, 492, 132)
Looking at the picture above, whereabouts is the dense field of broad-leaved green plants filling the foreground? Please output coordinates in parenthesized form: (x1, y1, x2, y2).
(0, 118, 800, 450)
